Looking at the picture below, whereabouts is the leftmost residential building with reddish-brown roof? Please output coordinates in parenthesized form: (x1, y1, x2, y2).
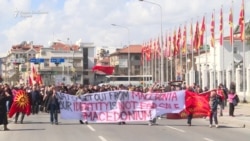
(2, 41, 43, 85)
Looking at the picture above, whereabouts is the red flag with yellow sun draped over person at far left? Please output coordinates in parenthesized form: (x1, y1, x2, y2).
(9, 90, 31, 118)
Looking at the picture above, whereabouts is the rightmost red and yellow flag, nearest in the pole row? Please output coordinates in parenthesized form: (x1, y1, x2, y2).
(239, 0, 245, 42)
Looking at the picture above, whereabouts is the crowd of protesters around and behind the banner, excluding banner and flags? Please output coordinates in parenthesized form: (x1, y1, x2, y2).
(0, 82, 237, 130)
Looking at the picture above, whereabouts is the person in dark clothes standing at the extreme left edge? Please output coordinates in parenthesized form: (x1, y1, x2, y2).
(0, 87, 11, 131)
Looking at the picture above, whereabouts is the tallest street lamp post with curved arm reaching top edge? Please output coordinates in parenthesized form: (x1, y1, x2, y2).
(139, 0, 164, 85)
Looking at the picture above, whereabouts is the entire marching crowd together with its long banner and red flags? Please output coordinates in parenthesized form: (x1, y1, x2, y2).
(0, 83, 239, 130)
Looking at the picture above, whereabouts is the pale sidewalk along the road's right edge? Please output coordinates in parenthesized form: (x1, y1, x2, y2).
(218, 103, 250, 129)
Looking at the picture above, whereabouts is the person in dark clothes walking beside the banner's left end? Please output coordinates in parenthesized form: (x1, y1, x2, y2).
(47, 88, 60, 125)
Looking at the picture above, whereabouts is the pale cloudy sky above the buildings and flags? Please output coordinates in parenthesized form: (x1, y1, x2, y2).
(0, 0, 250, 56)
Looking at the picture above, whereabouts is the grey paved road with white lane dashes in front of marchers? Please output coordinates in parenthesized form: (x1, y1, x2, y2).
(0, 113, 250, 141)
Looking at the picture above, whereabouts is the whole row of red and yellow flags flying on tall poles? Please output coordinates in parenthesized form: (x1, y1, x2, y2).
(141, 0, 245, 61)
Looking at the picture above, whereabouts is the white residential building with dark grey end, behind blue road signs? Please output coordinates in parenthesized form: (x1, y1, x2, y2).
(36, 42, 94, 85)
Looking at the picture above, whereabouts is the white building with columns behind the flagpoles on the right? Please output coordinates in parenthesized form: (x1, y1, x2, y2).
(193, 31, 250, 101)
